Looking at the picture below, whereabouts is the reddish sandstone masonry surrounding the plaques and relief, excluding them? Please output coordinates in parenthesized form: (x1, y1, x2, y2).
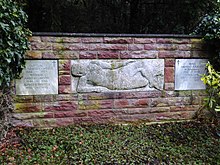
(13, 35, 207, 127)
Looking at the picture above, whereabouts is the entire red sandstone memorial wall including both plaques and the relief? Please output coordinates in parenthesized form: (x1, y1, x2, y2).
(13, 34, 208, 127)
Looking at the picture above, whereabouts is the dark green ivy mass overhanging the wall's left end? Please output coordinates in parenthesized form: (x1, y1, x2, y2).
(0, 0, 31, 89)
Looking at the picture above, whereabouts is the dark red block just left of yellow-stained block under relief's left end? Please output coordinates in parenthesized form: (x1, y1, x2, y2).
(44, 101, 77, 112)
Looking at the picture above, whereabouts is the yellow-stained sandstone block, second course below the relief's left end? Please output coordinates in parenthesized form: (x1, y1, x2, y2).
(79, 100, 114, 110)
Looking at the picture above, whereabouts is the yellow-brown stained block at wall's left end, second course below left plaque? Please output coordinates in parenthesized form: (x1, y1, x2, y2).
(14, 103, 43, 113)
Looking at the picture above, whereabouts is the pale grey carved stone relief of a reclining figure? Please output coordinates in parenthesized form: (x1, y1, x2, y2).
(71, 59, 164, 92)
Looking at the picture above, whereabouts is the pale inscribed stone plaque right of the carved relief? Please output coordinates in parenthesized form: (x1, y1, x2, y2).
(175, 59, 208, 90)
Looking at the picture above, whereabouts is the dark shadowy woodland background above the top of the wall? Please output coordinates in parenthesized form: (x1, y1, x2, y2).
(27, 0, 217, 34)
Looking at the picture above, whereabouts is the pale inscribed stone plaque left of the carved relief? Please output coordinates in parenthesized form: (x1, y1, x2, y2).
(16, 60, 58, 95)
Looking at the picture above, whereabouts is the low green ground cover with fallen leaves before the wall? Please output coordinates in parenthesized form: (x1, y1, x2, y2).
(0, 122, 220, 165)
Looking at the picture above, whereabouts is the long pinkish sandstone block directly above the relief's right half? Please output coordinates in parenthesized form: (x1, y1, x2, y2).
(120, 50, 158, 59)
